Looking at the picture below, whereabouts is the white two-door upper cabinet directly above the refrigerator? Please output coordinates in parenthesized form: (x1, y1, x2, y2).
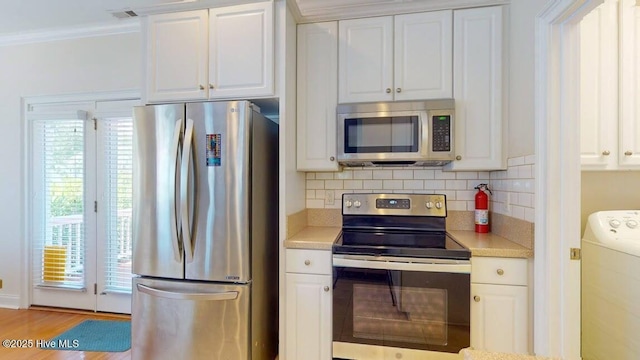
(145, 2, 274, 102)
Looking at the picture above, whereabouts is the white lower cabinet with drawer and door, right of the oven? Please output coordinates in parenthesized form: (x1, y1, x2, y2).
(471, 257, 529, 354)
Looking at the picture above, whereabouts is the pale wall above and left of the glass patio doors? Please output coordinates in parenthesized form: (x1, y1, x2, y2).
(0, 33, 142, 307)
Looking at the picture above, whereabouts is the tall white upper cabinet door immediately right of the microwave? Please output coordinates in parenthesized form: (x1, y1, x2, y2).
(446, 6, 506, 170)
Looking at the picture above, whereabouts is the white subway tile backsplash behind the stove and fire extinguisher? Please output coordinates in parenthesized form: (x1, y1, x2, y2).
(306, 155, 535, 222)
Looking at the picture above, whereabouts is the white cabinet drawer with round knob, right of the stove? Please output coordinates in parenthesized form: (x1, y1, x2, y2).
(471, 257, 527, 285)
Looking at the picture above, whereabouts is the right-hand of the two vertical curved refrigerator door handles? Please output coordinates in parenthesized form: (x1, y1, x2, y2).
(180, 119, 193, 263)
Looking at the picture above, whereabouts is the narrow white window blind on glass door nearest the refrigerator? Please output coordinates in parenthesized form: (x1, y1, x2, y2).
(97, 117, 133, 292)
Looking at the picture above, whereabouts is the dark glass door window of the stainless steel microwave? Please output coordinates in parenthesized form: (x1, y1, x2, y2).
(344, 116, 420, 154)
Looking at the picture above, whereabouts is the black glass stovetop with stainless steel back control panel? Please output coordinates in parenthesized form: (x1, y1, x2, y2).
(333, 193, 471, 260)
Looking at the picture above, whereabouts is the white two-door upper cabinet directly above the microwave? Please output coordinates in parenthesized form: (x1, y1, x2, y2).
(338, 10, 452, 103)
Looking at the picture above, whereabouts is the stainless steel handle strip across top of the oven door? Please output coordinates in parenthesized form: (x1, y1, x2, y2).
(333, 256, 471, 274)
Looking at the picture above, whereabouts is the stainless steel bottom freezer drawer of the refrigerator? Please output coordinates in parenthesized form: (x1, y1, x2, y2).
(131, 278, 251, 360)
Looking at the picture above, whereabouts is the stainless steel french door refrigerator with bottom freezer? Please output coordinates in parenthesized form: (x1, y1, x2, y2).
(131, 101, 278, 360)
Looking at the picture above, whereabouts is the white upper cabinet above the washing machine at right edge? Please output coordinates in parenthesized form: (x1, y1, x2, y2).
(580, 0, 640, 170)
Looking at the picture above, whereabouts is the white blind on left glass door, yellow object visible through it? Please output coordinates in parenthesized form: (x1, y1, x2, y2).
(31, 119, 86, 288)
